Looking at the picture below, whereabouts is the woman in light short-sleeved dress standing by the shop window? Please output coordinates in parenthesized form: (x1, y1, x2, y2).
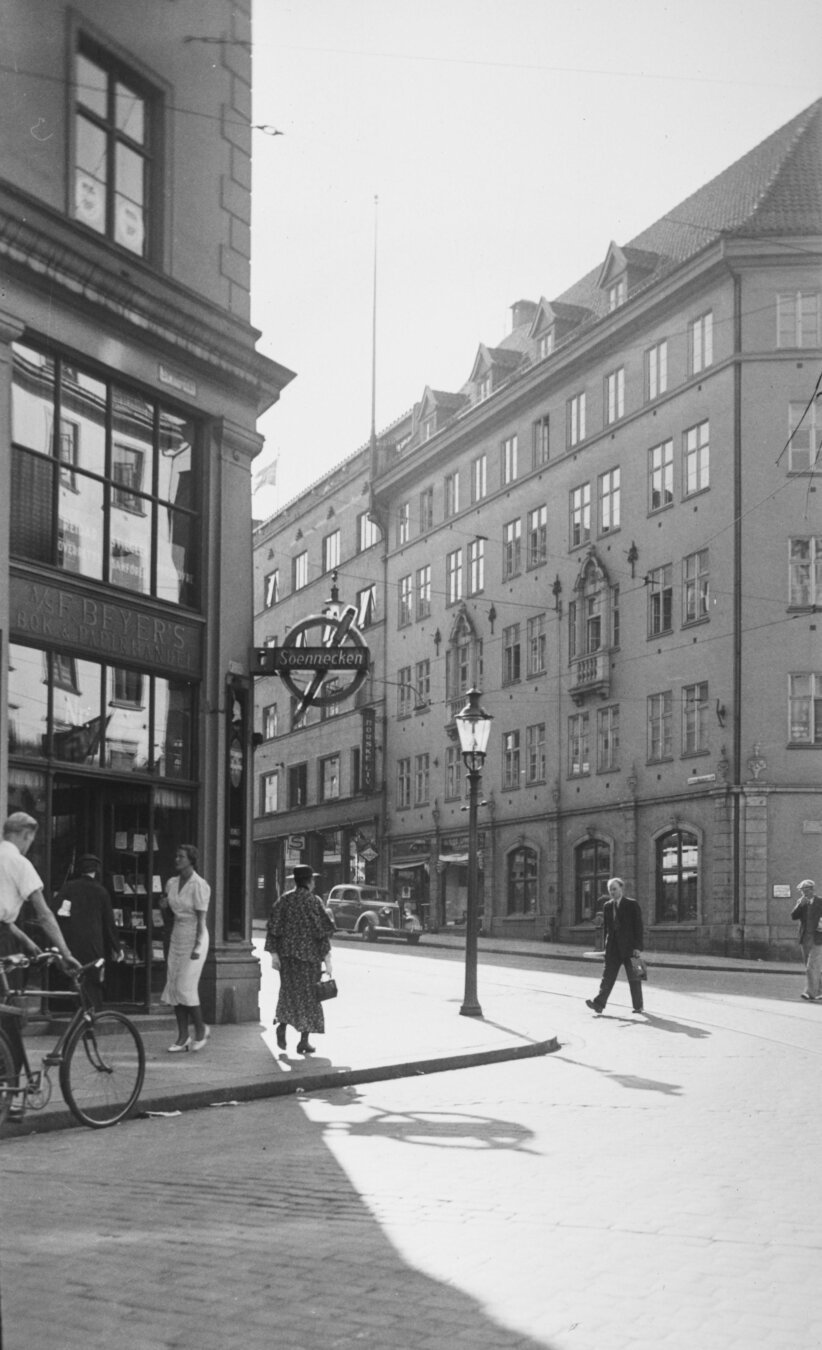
(162, 844, 211, 1054)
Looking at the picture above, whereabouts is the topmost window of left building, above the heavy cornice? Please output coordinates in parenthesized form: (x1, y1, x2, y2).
(72, 39, 157, 258)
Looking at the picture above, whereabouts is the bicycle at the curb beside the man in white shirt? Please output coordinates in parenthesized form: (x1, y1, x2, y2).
(0, 952, 146, 1130)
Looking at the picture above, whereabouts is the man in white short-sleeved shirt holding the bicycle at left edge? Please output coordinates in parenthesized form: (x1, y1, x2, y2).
(0, 811, 80, 1073)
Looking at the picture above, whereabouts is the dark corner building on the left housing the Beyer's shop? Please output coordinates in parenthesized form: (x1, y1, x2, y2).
(0, 0, 292, 1022)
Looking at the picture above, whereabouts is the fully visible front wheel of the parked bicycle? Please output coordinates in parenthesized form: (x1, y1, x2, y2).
(59, 1013, 146, 1130)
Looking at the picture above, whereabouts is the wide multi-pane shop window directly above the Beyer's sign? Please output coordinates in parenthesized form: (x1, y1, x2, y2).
(11, 343, 200, 608)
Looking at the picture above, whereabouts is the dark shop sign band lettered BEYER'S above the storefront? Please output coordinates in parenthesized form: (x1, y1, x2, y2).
(9, 574, 202, 678)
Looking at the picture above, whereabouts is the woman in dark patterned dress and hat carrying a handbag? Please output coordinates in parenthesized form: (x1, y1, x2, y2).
(266, 867, 333, 1054)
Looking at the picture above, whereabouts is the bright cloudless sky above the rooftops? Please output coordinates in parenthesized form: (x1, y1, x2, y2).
(251, 0, 822, 518)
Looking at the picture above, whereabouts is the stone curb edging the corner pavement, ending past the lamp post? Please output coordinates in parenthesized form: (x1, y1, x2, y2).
(3, 1035, 559, 1139)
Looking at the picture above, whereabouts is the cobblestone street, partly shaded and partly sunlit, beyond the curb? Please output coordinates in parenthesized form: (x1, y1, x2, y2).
(0, 949, 822, 1350)
